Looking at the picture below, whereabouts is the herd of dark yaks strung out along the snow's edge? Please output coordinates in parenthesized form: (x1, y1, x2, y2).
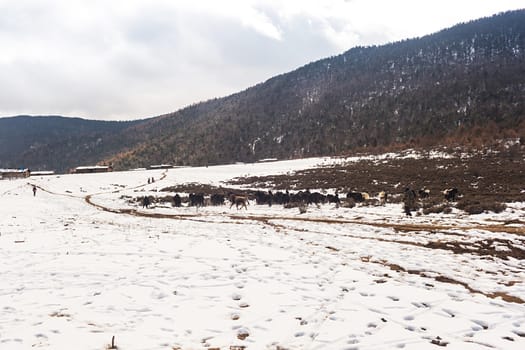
(142, 188, 459, 209)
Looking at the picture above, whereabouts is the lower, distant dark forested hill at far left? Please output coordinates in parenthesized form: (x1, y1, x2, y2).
(0, 116, 144, 172)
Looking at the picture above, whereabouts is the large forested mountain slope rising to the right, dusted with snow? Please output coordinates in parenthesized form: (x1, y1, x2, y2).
(0, 10, 525, 169)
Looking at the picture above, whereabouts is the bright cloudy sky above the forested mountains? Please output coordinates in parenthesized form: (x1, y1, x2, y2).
(0, 0, 525, 120)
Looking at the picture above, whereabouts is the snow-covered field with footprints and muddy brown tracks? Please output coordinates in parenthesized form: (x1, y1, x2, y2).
(0, 158, 525, 350)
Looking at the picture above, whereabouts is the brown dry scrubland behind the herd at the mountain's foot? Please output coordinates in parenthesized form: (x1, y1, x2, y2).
(227, 147, 525, 213)
